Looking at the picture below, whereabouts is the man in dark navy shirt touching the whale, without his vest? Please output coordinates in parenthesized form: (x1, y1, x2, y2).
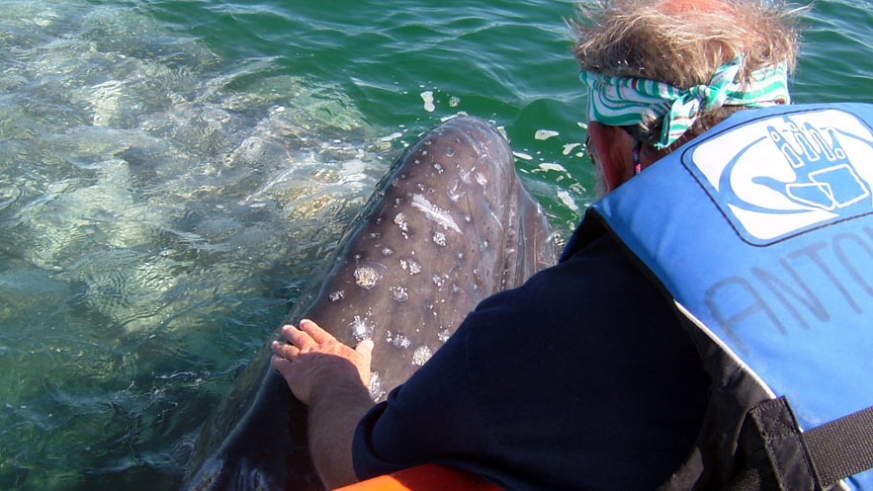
(273, 0, 796, 490)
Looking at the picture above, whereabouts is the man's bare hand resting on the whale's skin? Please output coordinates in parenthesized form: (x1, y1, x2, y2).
(271, 319, 373, 405)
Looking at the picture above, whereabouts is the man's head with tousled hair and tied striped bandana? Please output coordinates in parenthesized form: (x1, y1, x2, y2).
(574, 0, 798, 195)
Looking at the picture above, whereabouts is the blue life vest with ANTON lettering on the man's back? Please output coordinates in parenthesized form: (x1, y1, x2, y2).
(589, 103, 873, 490)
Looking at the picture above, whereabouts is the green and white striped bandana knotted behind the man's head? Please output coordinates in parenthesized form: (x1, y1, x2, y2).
(579, 55, 791, 149)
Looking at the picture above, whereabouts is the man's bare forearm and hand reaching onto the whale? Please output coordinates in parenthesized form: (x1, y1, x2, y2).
(272, 320, 373, 489)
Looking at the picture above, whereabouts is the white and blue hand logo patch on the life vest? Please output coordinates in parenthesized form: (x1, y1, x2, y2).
(683, 109, 873, 245)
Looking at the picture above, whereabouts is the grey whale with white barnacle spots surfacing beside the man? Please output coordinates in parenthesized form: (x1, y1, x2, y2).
(183, 117, 555, 491)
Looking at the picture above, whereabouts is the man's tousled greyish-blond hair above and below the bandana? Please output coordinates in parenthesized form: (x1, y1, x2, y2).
(571, 0, 801, 148)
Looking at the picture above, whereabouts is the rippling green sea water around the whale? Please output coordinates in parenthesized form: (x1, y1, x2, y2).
(0, 0, 873, 490)
